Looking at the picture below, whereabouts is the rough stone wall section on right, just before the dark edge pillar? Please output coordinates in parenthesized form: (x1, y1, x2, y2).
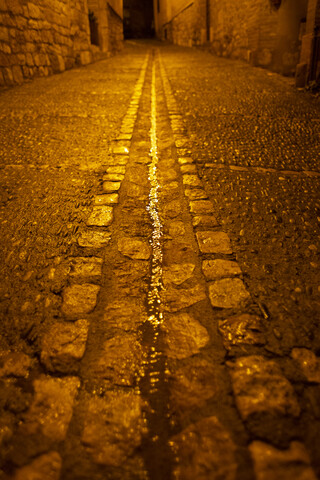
(210, 0, 308, 75)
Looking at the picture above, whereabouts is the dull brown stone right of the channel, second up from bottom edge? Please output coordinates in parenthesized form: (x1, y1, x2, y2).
(169, 357, 219, 415)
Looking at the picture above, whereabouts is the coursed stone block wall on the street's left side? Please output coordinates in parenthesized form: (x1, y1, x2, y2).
(0, 0, 92, 85)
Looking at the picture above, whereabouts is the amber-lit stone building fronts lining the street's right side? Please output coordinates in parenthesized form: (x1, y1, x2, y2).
(154, 0, 320, 86)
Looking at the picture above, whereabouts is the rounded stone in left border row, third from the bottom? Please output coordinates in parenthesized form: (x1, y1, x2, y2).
(40, 320, 88, 373)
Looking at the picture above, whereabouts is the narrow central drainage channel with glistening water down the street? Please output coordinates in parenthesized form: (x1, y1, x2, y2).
(139, 60, 172, 480)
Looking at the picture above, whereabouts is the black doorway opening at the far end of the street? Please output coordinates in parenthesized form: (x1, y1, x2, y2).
(123, 0, 154, 38)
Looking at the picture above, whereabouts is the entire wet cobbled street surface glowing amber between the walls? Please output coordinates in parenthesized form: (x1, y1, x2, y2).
(0, 42, 320, 480)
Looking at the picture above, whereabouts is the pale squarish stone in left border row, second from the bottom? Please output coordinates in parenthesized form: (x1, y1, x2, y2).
(21, 375, 80, 442)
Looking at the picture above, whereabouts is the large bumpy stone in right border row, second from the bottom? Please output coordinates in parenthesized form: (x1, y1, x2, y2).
(230, 355, 300, 420)
